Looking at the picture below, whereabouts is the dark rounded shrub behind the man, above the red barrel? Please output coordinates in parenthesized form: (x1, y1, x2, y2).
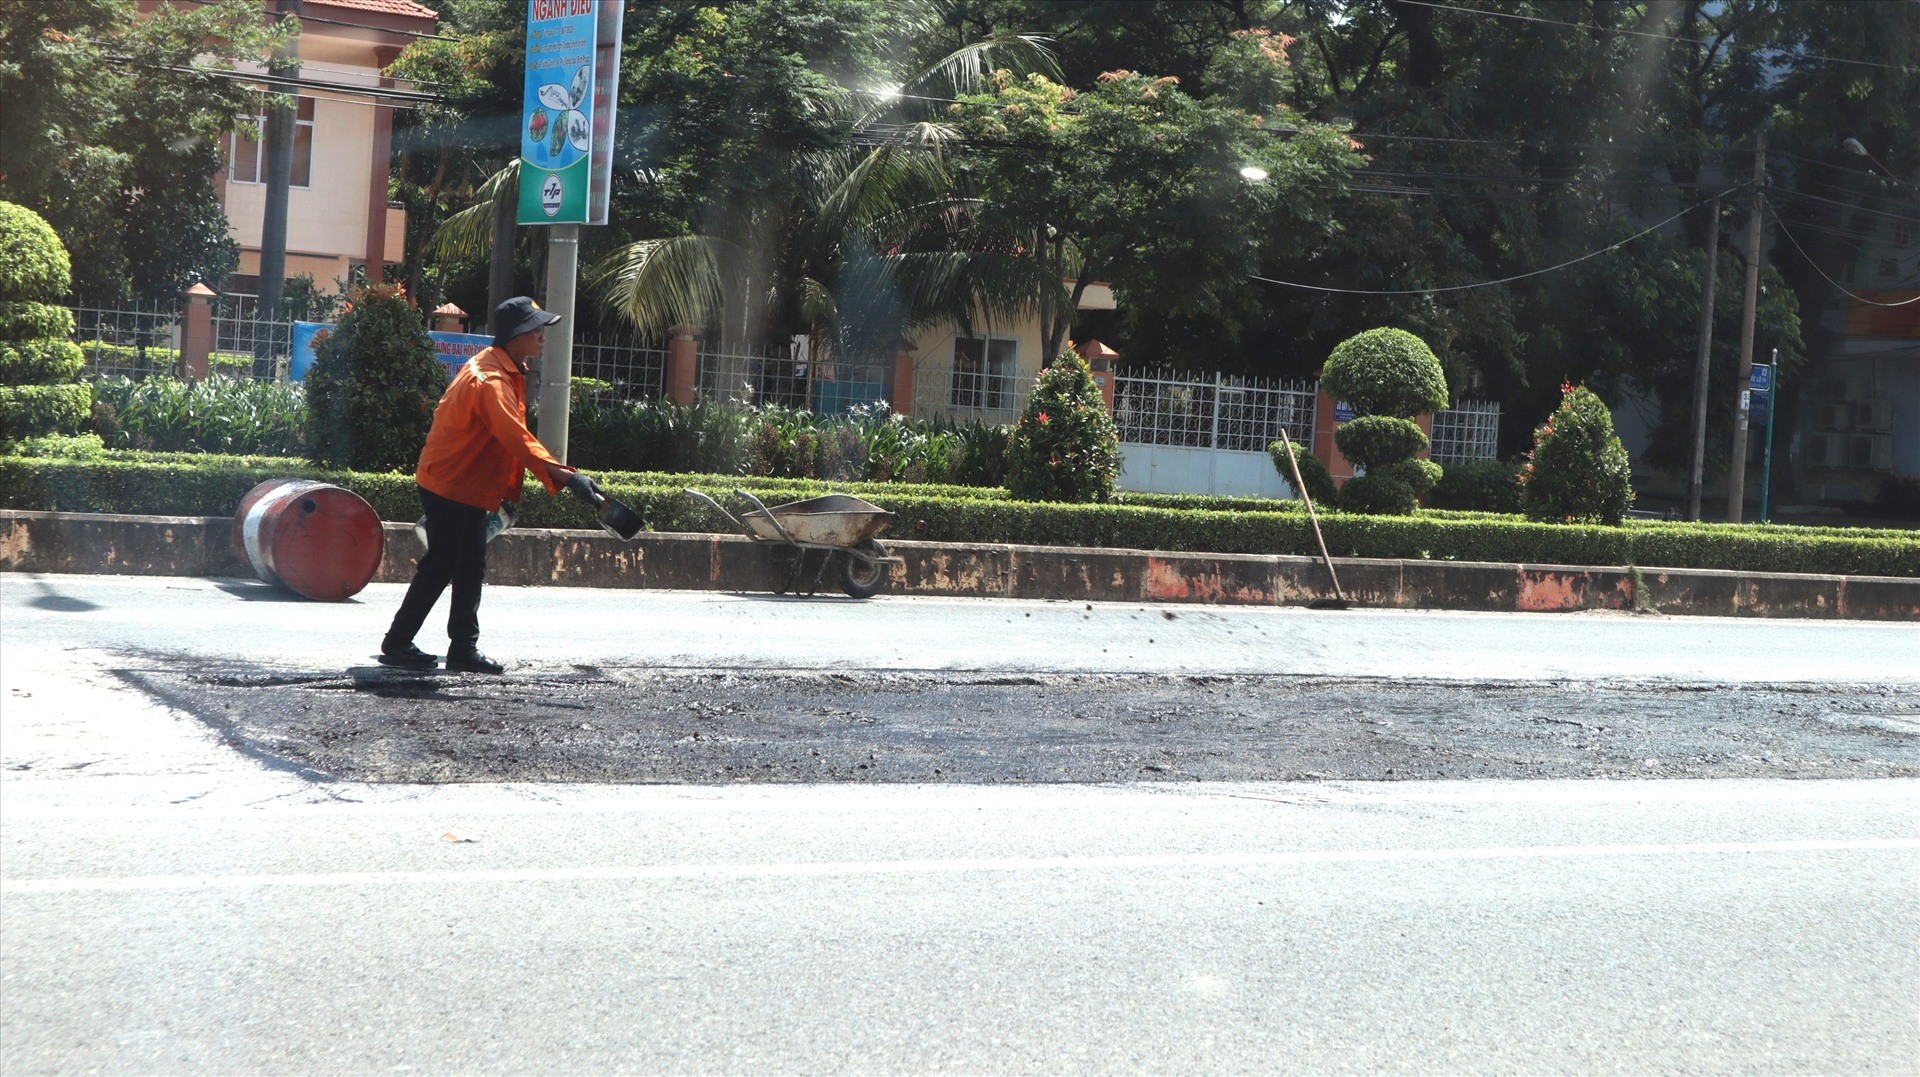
(307, 284, 447, 470)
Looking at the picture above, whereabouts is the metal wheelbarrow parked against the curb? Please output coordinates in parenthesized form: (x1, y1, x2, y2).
(687, 490, 904, 599)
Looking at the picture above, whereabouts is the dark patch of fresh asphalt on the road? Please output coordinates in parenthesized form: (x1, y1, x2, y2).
(121, 662, 1920, 783)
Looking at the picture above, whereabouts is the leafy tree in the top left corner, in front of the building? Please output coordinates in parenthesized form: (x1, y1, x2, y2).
(0, 0, 292, 301)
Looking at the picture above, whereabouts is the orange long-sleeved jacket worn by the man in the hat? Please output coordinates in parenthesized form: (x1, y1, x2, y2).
(413, 347, 566, 513)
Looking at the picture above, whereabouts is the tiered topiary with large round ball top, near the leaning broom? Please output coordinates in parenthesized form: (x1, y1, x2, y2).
(1321, 328, 1446, 515)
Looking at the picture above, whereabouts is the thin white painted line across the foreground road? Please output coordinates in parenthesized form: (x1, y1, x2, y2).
(0, 837, 1920, 895)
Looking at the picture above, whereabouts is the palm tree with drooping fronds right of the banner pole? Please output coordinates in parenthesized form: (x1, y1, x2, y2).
(589, 35, 1068, 403)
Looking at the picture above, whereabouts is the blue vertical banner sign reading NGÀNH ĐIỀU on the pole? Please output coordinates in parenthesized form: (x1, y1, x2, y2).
(518, 0, 599, 225)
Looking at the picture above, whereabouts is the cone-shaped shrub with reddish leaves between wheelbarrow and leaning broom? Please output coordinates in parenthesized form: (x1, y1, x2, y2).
(1006, 347, 1119, 501)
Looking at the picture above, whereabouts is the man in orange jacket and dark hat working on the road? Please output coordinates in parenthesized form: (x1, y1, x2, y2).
(380, 296, 593, 674)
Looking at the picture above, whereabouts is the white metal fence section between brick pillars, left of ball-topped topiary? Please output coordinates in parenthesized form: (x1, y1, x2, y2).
(1114, 371, 1317, 453)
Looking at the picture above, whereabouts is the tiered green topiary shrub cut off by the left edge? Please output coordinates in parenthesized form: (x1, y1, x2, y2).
(0, 202, 94, 442)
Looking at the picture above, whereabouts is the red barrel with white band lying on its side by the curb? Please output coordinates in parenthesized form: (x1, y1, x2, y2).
(234, 478, 386, 603)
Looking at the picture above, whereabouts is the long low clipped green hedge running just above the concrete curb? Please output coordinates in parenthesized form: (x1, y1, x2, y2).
(0, 453, 1920, 576)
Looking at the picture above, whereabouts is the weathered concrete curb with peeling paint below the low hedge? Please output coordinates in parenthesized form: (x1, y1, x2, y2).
(0, 509, 1920, 620)
